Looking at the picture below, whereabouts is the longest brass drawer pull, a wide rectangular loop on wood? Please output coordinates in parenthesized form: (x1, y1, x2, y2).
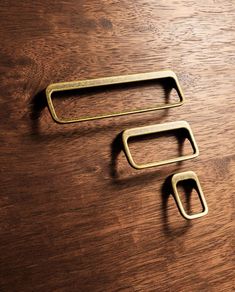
(46, 70, 185, 124)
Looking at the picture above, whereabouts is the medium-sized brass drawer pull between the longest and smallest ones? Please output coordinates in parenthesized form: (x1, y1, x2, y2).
(122, 121, 199, 169)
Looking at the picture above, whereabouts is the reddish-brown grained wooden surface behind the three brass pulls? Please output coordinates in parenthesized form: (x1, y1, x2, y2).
(0, 0, 235, 291)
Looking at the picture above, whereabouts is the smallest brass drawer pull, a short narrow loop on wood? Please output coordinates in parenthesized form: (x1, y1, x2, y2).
(171, 171, 208, 220)
